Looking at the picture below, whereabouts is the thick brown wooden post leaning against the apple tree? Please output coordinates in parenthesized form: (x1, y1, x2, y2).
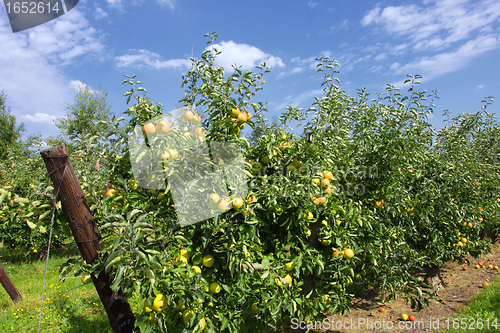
(40, 145, 140, 333)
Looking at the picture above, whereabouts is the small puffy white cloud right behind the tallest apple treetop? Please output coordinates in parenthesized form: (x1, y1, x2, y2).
(207, 41, 285, 72)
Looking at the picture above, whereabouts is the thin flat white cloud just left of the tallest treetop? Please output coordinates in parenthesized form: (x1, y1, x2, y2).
(116, 49, 191, 70)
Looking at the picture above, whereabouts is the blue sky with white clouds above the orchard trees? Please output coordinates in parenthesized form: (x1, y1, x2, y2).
(0, 0, 500, 141)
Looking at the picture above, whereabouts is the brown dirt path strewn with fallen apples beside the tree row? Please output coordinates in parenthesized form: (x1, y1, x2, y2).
(309, 241, 500, 333)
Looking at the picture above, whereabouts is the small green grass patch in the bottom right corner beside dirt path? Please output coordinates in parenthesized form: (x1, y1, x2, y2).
(442, 279, 500, 333)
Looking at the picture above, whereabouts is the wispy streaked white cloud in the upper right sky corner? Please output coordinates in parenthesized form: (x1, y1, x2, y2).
(361, 0, 500, 79)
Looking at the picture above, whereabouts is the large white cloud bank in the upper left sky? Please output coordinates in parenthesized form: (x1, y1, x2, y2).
(0, 7, 104, 135)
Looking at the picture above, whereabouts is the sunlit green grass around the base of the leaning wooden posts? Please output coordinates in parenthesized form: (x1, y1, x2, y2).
(0, 248, 147, 333)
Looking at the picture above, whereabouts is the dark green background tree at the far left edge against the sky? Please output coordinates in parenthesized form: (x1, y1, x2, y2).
(0, 91, 25, 159)
